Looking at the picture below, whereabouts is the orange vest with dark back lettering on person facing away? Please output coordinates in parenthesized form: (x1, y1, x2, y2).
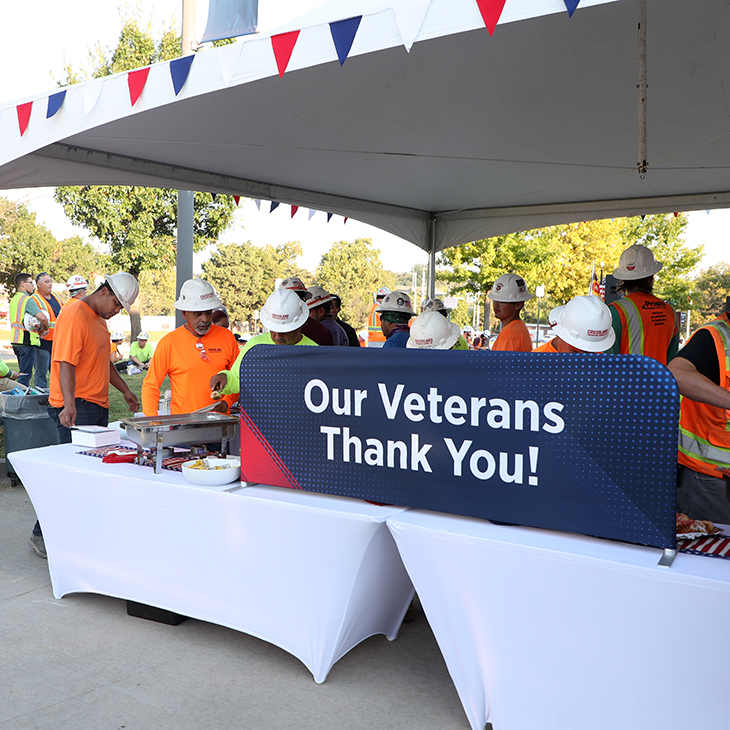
(610, 292, 679, 365)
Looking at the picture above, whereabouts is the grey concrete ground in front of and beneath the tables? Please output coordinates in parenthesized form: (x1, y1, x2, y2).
(0, 472, 474, 730)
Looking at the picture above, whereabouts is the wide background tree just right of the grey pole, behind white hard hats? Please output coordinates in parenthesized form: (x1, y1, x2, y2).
(203, 241, 307, 322)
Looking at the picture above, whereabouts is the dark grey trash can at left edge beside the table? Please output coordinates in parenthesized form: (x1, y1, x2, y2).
(0, 393, 58, 487)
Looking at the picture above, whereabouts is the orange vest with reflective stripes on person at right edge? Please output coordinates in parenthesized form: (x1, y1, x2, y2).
(677, 317, 730, 477)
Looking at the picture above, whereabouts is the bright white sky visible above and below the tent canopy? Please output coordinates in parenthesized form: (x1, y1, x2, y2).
(0, 0, 730, 272)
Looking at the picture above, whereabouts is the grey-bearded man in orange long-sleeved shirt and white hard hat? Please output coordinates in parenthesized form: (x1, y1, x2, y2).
(142, 279, 238, 416)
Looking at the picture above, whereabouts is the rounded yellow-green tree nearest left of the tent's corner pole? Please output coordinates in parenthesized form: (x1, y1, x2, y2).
(317, 238, 384, 329)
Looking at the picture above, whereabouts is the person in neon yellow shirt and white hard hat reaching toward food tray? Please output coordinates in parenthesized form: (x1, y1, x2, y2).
(208, 287, 317, 399)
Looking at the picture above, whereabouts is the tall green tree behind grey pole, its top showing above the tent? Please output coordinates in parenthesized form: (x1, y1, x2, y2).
(55, 18, 236, 338)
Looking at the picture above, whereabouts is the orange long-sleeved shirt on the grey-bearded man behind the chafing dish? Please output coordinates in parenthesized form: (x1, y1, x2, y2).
(142, 324, 238, 416)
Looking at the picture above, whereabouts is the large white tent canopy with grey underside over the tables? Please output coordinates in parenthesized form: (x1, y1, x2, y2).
(0, 0, 730, 252)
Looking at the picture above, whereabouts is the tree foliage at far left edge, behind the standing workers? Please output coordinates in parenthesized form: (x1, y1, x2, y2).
(0, 198, 109, 292)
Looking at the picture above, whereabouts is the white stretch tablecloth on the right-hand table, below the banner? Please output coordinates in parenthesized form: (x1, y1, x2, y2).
(388, 510, 730, 730)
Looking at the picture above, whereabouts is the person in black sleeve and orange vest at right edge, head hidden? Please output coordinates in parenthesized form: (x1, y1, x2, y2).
(668, 312, 730, 525)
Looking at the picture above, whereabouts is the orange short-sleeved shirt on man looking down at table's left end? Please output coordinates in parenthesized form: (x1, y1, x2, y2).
(48, 302, 114, 408)
